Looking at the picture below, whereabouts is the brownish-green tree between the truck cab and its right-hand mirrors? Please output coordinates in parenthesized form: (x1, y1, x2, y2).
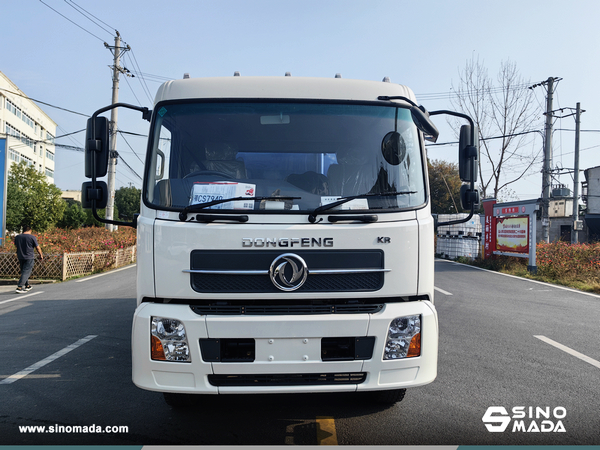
(427, 160, 462, 214)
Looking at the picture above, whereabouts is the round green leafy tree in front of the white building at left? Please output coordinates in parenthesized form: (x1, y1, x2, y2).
(6, 161, 66, 232)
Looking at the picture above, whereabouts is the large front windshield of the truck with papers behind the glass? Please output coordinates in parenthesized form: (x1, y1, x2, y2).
(144, 102, 425, 213)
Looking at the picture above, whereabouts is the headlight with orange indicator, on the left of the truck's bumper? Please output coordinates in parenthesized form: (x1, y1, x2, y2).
(150, 317, 192, 362)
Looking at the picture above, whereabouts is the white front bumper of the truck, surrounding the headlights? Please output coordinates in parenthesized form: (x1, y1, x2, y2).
(132, 301, 438, 394)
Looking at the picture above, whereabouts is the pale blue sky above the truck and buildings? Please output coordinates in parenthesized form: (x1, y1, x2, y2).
(0, 0, 600, 200)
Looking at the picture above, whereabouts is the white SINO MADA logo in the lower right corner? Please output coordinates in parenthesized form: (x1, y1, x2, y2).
(481, 406, 567, 433)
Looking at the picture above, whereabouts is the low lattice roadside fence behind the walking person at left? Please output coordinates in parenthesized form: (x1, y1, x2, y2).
(0, 246, 136, 281)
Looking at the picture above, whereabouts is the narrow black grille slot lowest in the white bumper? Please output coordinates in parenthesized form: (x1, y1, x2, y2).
(208, 372, 367, 387)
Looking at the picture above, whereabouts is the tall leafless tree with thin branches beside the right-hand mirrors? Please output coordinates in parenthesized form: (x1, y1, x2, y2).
(451, 57, 541, 198)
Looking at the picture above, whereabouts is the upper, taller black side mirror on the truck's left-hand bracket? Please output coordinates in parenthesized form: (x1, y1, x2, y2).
(85, 116, 110, 178)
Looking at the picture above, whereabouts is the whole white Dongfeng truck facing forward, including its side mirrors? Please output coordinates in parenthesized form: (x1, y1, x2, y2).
(82, 76, 479, 406)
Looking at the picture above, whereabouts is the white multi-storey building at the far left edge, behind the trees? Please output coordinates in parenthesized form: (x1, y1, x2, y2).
(0, 71, 56, 183)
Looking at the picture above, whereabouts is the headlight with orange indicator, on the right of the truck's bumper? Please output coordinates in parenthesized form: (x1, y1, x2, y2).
(383, 315, 421, 359)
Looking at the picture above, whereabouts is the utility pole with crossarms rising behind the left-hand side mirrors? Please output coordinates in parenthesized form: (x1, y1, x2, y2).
(104, 30, 131, 231)
